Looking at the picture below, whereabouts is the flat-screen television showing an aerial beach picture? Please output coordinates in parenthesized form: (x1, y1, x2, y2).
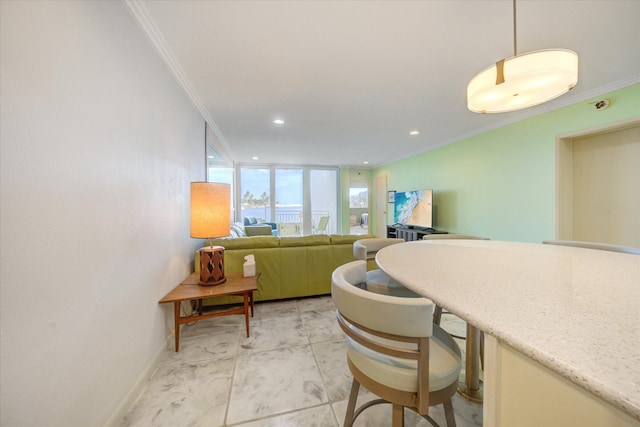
(393, 190, 433, 228)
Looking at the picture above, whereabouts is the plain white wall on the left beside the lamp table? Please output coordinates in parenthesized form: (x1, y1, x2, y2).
(0, 1, 204, 426)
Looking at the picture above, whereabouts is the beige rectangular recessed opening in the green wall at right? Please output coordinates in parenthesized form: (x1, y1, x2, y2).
(556, 119, 640, 247)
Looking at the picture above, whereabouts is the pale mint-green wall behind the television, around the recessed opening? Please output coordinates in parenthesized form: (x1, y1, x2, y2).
(370, 84, 640, 242)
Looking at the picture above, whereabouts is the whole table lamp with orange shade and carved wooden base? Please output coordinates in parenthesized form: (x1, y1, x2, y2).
(191, 182, 231, 286)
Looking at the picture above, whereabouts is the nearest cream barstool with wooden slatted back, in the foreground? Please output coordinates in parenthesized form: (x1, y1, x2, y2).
(331, 261, 461, 427)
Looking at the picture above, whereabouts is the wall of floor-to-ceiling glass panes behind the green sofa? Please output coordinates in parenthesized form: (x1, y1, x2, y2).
(235, 166, 339, 236)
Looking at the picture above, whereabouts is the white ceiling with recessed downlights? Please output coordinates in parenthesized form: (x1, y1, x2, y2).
(130, 0, 640, 168)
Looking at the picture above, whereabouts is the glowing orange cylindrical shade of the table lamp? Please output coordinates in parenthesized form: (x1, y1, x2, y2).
(191, 182, 231, 239)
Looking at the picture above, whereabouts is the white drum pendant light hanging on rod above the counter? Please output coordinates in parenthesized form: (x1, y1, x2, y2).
(467, 0, 578, 114)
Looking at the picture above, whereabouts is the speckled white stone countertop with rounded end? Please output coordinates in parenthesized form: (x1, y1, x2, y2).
(376, 240, 640, 420)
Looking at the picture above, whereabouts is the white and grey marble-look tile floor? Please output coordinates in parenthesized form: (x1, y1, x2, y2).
(121, 296, 482, 427)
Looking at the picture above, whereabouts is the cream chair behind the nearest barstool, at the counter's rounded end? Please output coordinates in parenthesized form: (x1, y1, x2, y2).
(353, 238, 420, 298)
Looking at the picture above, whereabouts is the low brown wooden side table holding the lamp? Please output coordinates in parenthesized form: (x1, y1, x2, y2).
(159, 273, 260, 352)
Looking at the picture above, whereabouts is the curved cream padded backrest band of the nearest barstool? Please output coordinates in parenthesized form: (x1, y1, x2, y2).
(331, 260, 435, 337)
